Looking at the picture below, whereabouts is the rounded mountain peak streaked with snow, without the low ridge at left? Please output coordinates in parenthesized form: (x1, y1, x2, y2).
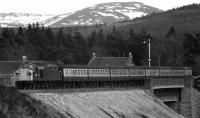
(50, 2, 162, 27)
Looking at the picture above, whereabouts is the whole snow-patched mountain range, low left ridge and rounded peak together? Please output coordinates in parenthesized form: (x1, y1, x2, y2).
(0, 2, 162, 27)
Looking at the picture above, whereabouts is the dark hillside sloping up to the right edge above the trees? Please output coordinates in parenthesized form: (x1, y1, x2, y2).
(113, 4, 200, 38)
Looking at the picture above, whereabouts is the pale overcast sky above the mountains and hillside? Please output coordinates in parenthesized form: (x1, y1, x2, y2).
(0, 0, 200, 14)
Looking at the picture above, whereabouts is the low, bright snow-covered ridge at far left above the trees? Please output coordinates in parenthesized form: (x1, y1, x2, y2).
(0, 13, 52, 27)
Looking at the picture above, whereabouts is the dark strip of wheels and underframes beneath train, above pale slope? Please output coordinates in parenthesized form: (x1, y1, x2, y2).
(16, 80, 144, 90)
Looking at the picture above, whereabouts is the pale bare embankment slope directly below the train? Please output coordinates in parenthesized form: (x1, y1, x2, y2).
(26, 89, 183, 118)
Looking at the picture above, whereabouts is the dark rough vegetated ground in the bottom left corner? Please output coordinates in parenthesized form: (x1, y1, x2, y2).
(0, 86, 64, 118)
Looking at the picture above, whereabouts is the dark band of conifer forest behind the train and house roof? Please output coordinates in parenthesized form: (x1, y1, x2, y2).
(0, 24, 200, 73)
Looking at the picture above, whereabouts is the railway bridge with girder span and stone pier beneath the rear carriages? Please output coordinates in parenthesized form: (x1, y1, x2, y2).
(151, 76, 192, 118)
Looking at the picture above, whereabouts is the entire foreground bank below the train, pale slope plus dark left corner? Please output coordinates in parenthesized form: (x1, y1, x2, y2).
(0, 86, 187, 118)
